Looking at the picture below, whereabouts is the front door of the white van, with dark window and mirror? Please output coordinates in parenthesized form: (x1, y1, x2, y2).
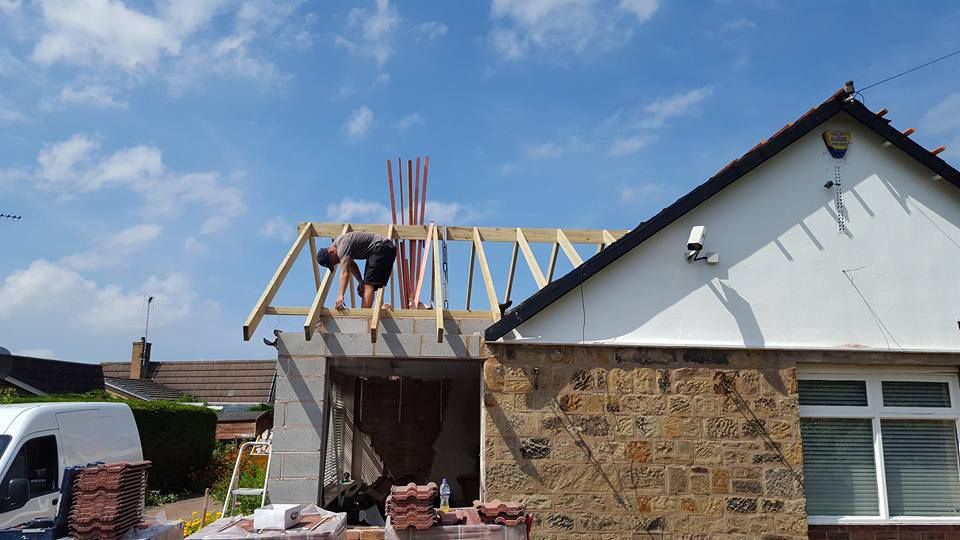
(0, 430, 60, 529)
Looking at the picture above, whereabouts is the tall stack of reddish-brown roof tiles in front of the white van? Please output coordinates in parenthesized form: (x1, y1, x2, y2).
(69, 461, 150, 540)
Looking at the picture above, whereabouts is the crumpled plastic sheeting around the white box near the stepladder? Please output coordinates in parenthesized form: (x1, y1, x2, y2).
(189, 504, 347, 540)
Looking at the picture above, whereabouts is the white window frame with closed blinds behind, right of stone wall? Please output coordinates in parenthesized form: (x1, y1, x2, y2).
(797, 366, 960, 525)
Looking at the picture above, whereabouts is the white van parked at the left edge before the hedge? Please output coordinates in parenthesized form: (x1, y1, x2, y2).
(0, 403, 143, 530)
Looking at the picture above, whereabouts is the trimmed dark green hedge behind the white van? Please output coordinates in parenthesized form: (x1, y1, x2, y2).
(0, 391, 217, 491)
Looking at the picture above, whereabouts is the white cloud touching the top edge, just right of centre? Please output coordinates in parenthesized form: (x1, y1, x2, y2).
(488, 0, 659, 60)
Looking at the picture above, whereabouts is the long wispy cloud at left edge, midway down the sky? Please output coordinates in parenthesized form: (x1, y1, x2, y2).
(0, 134, 246, 234)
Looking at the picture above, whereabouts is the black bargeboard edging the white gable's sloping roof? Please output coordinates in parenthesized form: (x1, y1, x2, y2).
(484, 89, 960, 342)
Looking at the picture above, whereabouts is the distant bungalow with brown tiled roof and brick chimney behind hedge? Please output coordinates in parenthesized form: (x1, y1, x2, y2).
(101, 339, 276, 440)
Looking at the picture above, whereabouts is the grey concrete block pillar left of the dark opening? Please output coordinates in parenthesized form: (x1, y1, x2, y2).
(269, 355, 327, 503)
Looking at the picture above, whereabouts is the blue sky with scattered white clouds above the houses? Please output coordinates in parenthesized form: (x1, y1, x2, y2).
(0, 0, 960, 362)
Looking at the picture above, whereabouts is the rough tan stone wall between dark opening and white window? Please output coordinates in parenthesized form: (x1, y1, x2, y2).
(483, 344, 807, 539)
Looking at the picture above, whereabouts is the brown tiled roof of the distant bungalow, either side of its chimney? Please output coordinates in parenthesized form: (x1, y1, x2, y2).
(101, 360, 277, 403)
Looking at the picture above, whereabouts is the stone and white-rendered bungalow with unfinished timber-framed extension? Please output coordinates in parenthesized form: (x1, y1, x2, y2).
(244, 84, 960, 540)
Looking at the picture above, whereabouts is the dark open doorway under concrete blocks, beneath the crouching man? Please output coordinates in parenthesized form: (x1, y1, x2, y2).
(321, 358, 481, 525)
